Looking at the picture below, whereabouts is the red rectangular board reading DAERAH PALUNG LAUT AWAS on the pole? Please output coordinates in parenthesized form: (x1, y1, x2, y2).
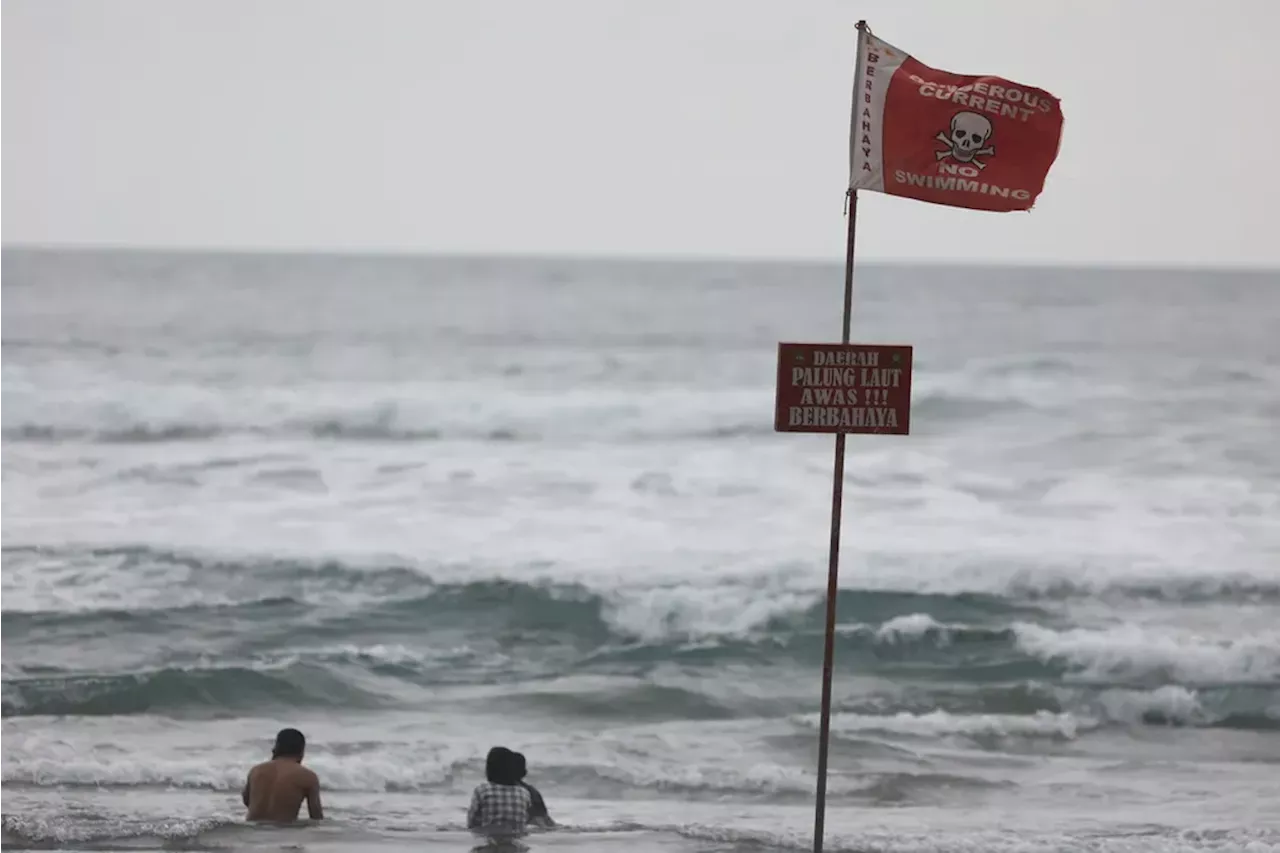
(773, 343, 911, 435)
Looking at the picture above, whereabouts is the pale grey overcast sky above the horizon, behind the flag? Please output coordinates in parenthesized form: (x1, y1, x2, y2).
(0, 0, 1280, 266)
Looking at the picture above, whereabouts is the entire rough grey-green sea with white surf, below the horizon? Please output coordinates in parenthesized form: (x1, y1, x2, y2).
(0, 252, 1280, 853)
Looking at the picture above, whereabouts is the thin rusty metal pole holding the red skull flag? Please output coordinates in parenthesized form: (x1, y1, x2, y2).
(813, 20, 867, 853)
